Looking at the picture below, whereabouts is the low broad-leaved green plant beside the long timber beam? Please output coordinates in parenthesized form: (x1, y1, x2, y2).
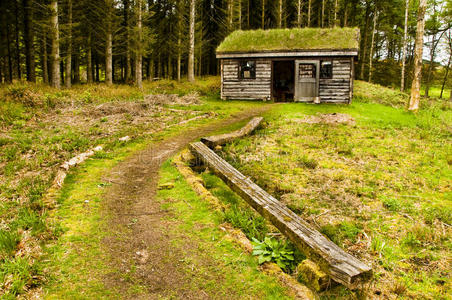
(251, 237, 300, 271)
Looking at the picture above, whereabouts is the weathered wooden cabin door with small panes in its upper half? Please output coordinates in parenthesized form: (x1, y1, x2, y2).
(294, 60, 320, 102)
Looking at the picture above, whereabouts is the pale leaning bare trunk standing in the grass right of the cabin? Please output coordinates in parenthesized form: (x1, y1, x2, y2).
(408, 0, 427, 111)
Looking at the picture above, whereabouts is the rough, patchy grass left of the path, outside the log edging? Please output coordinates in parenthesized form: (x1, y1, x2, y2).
(0, 78, 259, 296)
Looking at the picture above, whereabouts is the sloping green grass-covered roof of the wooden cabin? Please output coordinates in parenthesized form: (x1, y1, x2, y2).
(217, 27, 359, 53)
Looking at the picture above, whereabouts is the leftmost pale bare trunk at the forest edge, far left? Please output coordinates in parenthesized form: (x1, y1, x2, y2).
(50, 0, 61, 89)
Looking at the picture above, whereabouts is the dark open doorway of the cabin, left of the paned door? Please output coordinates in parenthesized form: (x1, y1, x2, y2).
(273, 60, 295, 102)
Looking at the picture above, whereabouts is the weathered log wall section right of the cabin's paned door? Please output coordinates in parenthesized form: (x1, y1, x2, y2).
(319, 58, 354, 103)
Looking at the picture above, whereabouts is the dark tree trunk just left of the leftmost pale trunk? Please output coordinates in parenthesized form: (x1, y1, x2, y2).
(22, 0, 36, 82)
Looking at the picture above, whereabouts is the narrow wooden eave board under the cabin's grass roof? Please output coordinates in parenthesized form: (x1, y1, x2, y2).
(216, 49, 358, 59)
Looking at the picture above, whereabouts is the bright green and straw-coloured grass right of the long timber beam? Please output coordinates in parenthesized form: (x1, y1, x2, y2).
(220, 82, 452, 299)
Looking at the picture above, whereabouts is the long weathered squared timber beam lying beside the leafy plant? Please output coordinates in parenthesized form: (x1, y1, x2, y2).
(189, 142, 372, 289)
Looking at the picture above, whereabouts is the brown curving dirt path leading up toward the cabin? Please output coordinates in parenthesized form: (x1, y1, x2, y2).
(104, 105, 271, 299)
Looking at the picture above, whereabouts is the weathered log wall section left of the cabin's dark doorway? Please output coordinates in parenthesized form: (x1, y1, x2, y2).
(221, 59, 272, 100)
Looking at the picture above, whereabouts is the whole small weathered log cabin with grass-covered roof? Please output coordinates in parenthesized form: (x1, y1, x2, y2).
(216, 28, 359, 103)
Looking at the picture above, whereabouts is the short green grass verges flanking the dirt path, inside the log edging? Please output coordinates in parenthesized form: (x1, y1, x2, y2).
(41, 144, 289, 299)
